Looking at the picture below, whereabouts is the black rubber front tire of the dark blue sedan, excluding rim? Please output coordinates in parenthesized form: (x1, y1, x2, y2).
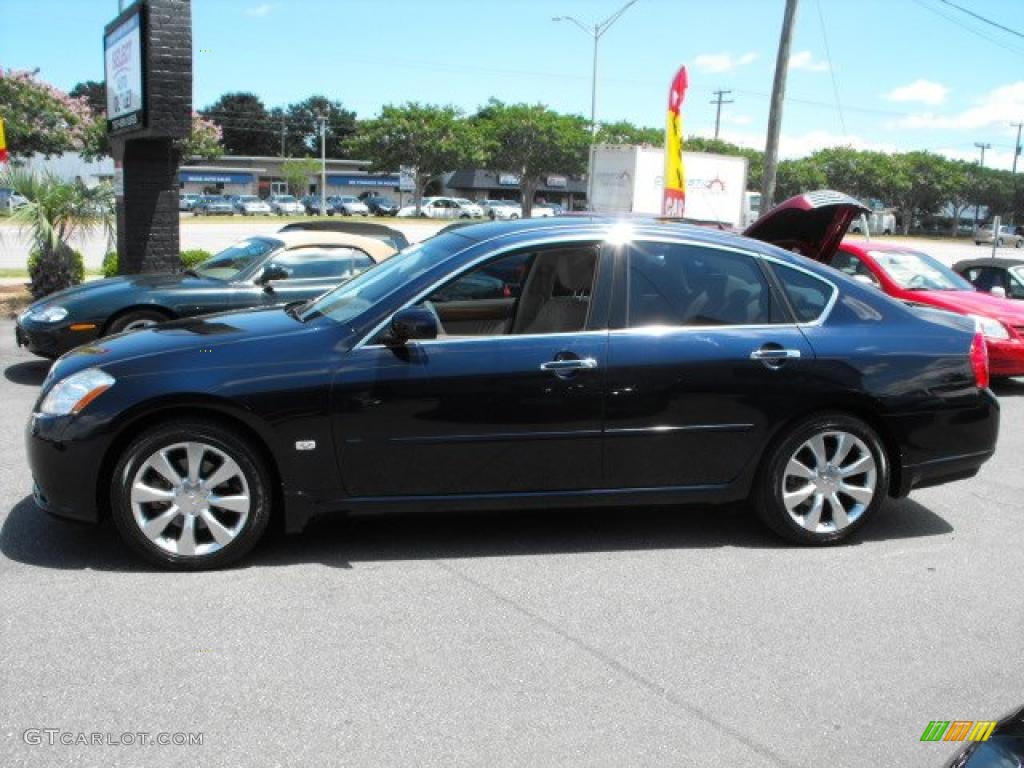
(111, 420, 272, 570)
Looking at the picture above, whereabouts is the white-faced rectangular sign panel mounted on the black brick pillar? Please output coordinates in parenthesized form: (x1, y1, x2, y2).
(103, 10, 145, 133)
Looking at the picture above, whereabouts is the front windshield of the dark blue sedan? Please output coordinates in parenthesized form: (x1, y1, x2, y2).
(300, 234, 468, 323)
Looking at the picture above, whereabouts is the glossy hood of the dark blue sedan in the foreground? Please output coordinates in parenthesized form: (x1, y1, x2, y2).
(47, 307, 315, 380)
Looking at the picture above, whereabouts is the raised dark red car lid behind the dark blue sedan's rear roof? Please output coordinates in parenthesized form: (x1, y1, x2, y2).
(743, 189, 870, 262)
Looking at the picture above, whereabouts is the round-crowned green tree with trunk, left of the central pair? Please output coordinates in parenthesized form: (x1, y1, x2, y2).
(347, 101, 483, 213)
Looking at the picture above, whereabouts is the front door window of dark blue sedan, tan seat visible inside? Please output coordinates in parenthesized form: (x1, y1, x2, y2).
(425, 245, 598, 336)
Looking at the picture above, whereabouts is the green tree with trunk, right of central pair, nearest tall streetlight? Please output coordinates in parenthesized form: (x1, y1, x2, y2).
(474, 100, 591, 217)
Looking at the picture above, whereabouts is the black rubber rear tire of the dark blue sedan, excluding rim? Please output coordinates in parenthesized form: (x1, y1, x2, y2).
(754, 413, 889, 546)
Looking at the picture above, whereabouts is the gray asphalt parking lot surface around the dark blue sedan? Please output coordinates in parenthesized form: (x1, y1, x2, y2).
(0, 321, 1024, 767)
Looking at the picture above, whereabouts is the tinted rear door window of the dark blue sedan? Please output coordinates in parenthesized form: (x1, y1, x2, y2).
(626, 243, 781, 328)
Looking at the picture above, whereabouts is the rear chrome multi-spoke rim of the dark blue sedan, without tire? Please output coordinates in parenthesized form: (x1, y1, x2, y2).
(782, 431, 878, 534)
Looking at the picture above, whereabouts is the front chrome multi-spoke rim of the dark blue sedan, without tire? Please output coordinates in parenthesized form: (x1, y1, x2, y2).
(131, 442, 252, 557)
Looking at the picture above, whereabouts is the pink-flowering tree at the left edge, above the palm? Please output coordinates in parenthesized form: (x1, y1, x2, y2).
(0, 68, 92, 158)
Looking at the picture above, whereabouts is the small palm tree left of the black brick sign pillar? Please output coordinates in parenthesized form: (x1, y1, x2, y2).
(0, 168, 114, 299)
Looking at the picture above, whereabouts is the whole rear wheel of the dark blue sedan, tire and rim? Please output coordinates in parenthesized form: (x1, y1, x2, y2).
(757, 414, 889, 544)
